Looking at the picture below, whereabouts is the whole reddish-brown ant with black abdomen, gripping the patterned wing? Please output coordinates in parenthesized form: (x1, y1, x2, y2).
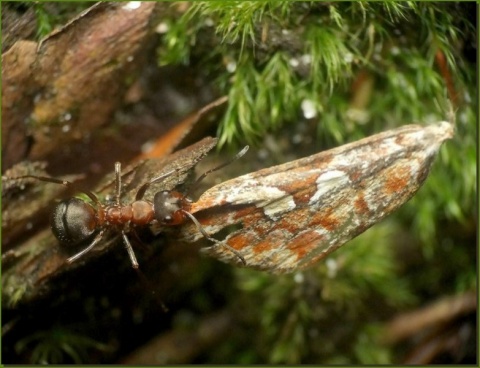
(17, 146, 249, 269)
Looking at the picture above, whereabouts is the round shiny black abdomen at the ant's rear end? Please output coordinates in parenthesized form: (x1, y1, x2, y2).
(50, 198, 97, 246)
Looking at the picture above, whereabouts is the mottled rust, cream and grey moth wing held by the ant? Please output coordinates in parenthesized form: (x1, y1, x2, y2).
(181, 122, 454, 273)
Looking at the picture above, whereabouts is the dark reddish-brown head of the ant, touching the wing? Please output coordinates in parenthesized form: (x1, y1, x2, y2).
(153, 190, 190, 225)
